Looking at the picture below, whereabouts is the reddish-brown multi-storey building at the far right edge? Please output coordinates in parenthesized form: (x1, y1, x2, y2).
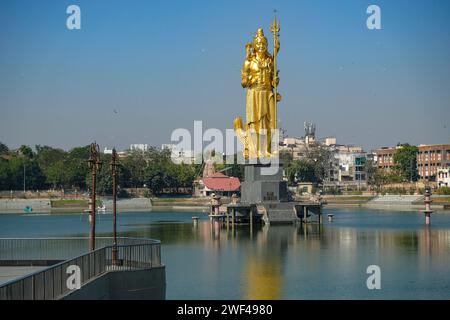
(417, 144, 450, 181)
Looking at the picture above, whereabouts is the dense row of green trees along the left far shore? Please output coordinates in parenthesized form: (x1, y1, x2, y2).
(0, 143, 201, 195)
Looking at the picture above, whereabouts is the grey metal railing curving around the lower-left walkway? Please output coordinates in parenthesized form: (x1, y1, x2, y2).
(0, 238, 162, 300)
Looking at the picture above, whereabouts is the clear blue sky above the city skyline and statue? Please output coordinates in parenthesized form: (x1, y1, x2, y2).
(0, 0, 450, 150)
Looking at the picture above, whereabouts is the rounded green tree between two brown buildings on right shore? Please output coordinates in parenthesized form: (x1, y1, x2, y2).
(394, 143, 419, 181)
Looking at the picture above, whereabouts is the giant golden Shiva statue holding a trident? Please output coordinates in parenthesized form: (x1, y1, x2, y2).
(234, 19, 281, 159)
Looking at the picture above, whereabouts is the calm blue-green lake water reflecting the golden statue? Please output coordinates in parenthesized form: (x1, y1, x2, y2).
(0, 209, 450, 299)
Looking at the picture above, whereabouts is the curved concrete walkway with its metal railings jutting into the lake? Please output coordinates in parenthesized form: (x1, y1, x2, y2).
(0, 238, 166, 300)
